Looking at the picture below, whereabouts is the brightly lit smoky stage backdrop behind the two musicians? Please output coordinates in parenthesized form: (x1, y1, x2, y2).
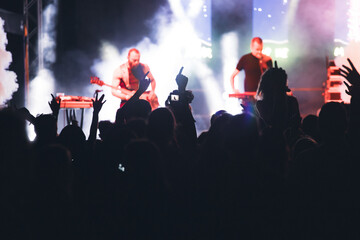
(0, 0, 359, 134)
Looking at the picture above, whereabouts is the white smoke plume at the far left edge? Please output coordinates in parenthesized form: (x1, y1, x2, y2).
(0, 18, 19, 105)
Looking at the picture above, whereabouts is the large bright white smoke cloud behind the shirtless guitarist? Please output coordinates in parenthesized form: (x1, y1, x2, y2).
(91, 0, 222, 129)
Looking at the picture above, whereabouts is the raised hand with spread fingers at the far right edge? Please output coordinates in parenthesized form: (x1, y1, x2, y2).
(340, 58, 360, 96)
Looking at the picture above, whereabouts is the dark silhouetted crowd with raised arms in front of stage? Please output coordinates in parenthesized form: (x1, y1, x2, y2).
(0, 60, 360, 240)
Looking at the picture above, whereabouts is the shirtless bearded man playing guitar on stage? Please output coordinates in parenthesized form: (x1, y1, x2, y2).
(111, 48, 159, 109)
